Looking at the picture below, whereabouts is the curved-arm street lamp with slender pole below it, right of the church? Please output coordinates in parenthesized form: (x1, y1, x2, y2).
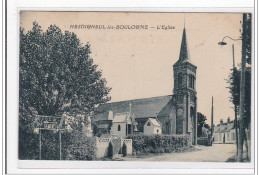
(218, 36, 242, 155)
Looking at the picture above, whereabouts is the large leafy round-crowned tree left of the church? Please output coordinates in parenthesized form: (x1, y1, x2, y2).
(19, 22, 110, 159)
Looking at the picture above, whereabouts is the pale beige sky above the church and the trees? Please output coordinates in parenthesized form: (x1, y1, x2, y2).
(20, 11, 242, 125)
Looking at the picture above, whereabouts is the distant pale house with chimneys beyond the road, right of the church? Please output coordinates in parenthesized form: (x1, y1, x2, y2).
(213, 117, 236, 143)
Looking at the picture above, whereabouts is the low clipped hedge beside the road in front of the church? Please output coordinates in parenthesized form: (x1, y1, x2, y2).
(127, 135, 189, 155)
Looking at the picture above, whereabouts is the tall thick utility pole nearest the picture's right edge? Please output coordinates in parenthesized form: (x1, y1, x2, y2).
(238, 13, 247, 162)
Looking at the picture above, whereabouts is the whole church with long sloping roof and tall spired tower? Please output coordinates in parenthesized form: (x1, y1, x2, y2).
(92, 27, 197, 145)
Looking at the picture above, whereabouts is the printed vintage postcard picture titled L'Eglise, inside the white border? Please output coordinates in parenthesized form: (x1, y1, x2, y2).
(18, 10, 254, 165)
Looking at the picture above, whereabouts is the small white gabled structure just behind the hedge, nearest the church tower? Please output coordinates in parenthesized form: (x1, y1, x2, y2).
(144, 118, 162, 135)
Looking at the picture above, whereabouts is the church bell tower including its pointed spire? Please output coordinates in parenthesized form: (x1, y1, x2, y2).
(172, 27, 197, 145)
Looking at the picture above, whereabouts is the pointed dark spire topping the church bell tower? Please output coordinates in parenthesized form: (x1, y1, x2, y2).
(174, 28, 192, 66)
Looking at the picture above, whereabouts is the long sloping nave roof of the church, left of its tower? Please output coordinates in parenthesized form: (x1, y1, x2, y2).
(94, 95, 172, 121)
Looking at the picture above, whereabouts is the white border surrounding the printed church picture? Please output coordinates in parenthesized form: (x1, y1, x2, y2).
(6, 0, 257, 174)
